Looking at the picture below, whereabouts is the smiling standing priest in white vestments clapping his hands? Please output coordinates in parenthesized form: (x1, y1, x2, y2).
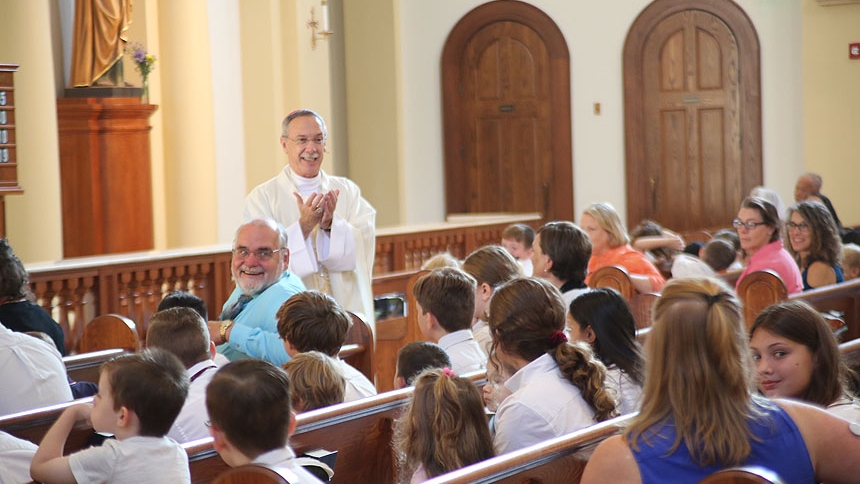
(244, 110, 376, 325)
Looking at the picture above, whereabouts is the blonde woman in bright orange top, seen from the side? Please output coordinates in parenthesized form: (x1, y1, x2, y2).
(579, 203, 666, 292)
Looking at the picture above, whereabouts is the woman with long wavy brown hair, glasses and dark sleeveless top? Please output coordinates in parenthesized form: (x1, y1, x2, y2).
(785, 201, 845, 291)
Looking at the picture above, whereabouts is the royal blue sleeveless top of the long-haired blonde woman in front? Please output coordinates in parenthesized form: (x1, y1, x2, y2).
(630, 404, 815, 484)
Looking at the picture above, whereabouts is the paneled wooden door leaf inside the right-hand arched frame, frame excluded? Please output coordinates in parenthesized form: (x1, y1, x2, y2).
(628, 10, 754, 231)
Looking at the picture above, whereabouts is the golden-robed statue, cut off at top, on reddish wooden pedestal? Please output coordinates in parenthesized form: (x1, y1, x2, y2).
(69, 0, 131, 87)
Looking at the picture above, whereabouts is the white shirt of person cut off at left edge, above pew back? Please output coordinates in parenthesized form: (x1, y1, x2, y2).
(0, 324, 72, 415)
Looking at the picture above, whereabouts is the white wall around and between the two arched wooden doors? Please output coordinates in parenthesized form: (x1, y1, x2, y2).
(400, 0, 803, 224)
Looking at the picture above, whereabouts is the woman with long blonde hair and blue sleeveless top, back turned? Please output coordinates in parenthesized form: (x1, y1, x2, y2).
(581, 278, 860, 484)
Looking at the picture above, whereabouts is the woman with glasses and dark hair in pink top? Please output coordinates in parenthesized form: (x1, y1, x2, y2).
(732, 197, 803, 294)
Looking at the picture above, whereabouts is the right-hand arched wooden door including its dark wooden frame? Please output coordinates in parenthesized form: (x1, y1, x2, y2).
(624, 0, 762, 231)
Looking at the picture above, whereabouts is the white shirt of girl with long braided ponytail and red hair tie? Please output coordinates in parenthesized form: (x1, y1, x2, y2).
(493, 354, 595, 454)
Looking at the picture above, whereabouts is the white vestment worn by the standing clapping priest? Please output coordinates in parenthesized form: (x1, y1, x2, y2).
(243, 166, 376, 327)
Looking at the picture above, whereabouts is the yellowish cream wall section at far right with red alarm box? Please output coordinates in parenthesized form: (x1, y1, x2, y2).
(803, 0, 860, 226)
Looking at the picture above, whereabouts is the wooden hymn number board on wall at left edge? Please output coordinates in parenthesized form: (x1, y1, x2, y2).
(0, 64, 24, 237)
